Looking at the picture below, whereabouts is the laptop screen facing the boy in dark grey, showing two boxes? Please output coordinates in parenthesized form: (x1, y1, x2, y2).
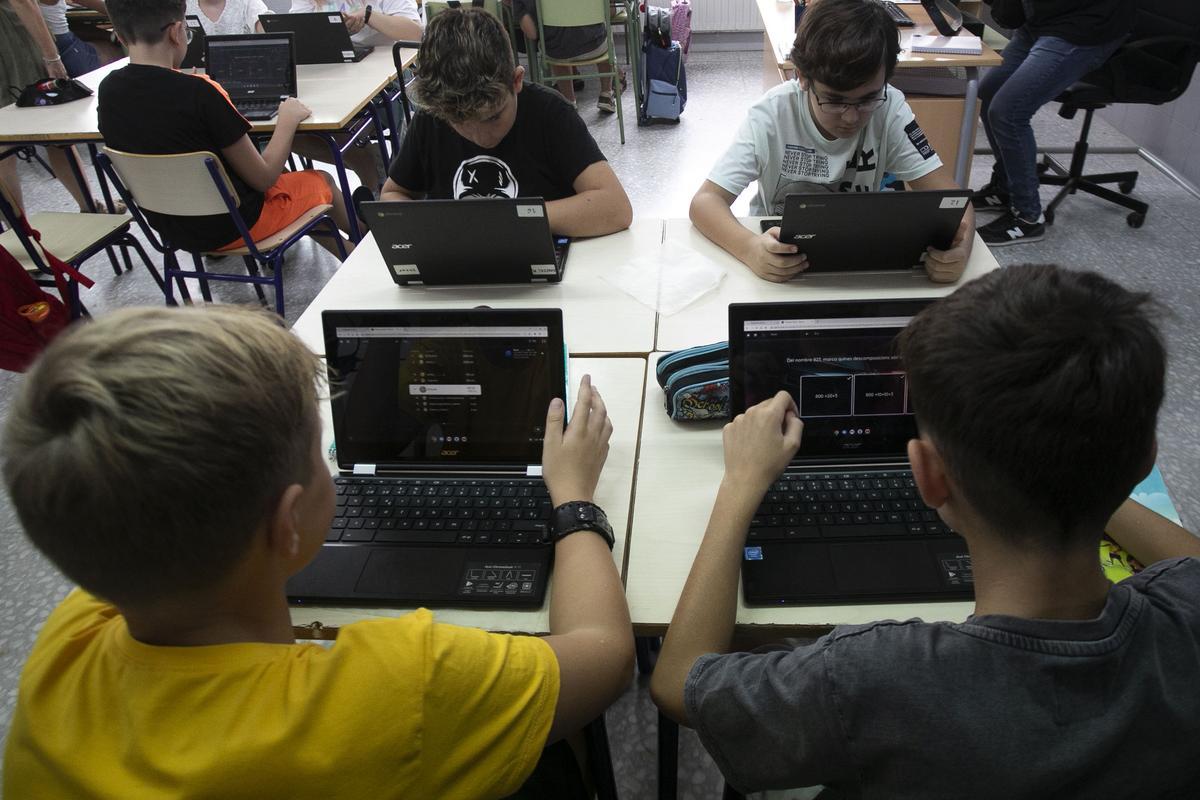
(730, 300, 930, 461)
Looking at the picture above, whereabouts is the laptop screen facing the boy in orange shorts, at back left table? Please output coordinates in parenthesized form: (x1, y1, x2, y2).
(205, 35, 295, 98)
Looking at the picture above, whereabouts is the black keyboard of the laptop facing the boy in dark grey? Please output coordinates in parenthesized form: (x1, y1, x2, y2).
(746, 470, 954, 541)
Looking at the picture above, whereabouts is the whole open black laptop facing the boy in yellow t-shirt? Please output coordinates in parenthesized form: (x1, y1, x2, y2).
(288, 308, 566, 607)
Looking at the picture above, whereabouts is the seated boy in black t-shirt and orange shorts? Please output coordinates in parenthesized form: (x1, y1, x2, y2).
(98, 0, 353, 254)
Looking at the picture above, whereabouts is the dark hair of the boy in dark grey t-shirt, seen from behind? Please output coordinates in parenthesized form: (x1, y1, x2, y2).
(896, 265, 1166, 548)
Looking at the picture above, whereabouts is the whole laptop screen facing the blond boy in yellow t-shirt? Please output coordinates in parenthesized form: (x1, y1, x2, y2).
(324, 308, 566, 469)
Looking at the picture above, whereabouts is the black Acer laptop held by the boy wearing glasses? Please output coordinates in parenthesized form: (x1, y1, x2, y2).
(761, 190, 971, 275)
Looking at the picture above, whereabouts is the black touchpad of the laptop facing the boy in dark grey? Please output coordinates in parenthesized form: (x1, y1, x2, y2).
(829, 542, 941, 594)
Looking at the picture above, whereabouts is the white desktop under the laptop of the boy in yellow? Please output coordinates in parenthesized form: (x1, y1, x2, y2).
(292, 359, 646, 633)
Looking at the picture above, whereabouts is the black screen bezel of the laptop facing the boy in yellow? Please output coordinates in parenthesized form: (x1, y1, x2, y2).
(322, 308, 568, 473)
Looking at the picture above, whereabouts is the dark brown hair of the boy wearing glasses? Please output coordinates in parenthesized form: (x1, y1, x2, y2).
(792, 0, 900, 91)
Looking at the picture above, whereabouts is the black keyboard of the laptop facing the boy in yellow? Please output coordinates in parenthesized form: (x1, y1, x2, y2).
(325, 477, 551, 547)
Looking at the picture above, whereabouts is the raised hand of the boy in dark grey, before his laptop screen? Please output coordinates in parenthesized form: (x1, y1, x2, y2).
(724, 391, 804, 503)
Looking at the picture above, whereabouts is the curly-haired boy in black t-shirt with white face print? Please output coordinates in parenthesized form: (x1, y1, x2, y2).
(382, 8, 634, 236)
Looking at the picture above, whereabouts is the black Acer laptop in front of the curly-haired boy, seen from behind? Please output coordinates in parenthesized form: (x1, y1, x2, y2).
(362, 197, 570, 285)
